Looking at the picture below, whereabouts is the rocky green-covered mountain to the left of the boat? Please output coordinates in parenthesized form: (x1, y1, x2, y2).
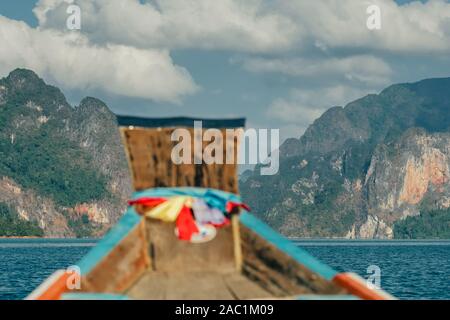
(0, 69, 131, 237)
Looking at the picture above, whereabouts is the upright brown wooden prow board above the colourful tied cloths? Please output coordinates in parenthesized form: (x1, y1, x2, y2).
(121, 128, 243, 194)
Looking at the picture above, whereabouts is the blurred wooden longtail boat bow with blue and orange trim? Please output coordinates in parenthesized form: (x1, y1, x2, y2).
(27, 116, 394, 300)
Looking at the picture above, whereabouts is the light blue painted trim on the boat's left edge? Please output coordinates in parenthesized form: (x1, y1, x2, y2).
(77, 207, 142, 275)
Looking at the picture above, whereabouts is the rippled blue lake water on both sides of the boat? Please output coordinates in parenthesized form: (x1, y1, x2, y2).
(0, 239, 450, 299)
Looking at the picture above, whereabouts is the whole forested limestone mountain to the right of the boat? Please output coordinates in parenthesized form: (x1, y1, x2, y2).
(241, 79, 450, 238)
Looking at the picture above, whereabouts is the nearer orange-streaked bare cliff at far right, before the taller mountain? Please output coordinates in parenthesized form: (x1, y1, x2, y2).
(360, 129, 450, 238)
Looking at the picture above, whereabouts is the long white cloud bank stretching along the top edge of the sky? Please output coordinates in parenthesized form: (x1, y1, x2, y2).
(35, 0, 450, 53)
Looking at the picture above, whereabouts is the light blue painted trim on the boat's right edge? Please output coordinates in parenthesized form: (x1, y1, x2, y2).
(240, 212, 338, 281)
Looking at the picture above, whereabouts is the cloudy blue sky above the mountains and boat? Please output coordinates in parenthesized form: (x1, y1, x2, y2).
(0, 0, 450, 139)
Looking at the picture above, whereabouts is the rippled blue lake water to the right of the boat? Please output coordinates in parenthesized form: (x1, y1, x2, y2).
(295, 240, 450, 299)
